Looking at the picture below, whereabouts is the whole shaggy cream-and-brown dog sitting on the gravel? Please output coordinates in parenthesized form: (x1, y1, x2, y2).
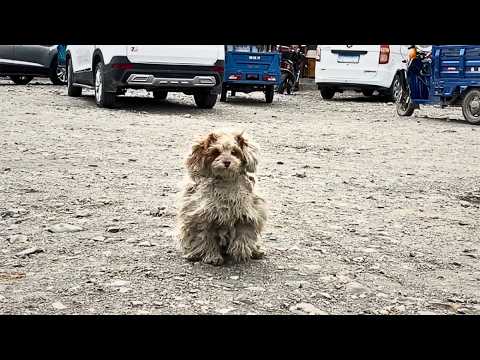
(177, 131, 267, 265)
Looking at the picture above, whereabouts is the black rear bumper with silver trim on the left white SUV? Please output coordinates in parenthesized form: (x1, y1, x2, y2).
(105, 57, 223, 94)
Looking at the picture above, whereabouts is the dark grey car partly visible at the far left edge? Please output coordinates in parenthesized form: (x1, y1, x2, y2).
(0, 45, 66, 85)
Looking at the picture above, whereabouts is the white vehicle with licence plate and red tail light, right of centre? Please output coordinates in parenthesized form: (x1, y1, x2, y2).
(315, 45, 408, 100)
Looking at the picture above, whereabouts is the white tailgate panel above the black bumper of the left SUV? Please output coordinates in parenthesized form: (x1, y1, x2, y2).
(127, 45, 224, 65)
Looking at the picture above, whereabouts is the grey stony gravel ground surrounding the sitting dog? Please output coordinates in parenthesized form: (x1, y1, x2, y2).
(0, 80, 480, 314)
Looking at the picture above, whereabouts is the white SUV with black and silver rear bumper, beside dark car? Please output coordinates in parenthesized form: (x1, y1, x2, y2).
(66, 45, 225, 108)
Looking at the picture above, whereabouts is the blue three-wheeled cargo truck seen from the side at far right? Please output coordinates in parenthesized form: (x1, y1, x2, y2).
(396, 45, 480, 124)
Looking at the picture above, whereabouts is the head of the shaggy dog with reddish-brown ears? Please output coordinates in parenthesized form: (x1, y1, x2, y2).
(187, 131, 258, 178)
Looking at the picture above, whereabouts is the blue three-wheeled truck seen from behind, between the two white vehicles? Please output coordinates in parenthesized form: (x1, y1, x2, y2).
(220, 45, 281, 103)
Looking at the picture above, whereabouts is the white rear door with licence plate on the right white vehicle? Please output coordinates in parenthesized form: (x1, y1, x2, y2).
(319, 45, 380, 83)
